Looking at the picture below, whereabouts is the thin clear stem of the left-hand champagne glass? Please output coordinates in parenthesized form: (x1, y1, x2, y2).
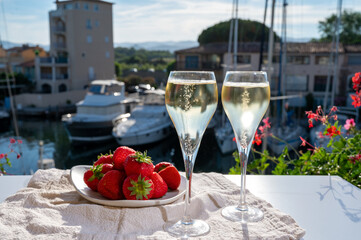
(182, 155, 194, 225)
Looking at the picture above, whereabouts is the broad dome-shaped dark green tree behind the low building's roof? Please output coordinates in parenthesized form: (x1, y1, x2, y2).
(198, 19, 280, 45)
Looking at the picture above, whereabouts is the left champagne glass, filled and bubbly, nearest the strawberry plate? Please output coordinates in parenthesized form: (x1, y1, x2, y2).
(164, 71, 218, 237)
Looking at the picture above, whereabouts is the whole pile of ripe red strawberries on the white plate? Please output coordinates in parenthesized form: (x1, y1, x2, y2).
(84, 146, 181, 200)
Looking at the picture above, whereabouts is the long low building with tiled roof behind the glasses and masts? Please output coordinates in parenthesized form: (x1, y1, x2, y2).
(175, 42, 361, 105)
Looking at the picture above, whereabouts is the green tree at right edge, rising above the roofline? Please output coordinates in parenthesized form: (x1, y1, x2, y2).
(314, 10, 361, 44)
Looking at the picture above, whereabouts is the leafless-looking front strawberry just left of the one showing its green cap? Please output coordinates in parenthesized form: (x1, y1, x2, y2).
(98, 170, 126, 200)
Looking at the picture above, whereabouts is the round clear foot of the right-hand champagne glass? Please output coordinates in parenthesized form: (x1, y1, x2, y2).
(222, 206, 263, 223)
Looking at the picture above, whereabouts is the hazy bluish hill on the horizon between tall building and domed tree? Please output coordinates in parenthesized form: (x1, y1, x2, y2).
(114, 41, 198, 52)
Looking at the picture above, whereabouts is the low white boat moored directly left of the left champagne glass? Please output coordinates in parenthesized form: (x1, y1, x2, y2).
(113, 105, 172, 146)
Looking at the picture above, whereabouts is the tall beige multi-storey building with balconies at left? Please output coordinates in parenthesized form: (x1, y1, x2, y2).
(36, 0, 114, 93)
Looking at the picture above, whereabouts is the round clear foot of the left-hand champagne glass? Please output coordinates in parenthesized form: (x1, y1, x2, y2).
(163, 220, 210, 237)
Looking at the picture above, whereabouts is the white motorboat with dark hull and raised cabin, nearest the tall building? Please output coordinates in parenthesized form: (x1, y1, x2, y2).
(61, 80, 139, 144)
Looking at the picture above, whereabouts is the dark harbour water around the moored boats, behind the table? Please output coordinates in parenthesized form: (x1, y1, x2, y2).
(0, 119, 234, 175)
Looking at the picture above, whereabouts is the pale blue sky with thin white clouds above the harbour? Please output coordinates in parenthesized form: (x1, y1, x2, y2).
(0, 0, 361, 44)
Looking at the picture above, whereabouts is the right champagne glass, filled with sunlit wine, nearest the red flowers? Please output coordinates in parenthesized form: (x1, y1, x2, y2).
(222, 71, 270, 223)
